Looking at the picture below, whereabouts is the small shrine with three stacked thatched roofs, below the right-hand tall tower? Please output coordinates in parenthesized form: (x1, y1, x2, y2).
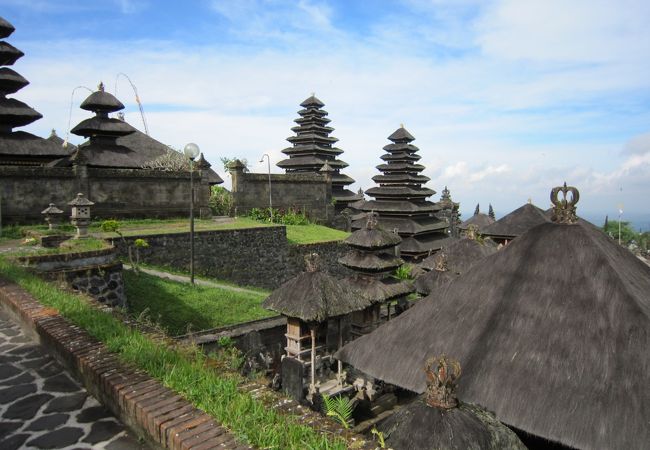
(339, 213, 414, 339)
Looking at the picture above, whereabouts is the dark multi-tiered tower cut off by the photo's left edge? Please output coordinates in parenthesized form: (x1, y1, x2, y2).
(0, 17, 68, 166)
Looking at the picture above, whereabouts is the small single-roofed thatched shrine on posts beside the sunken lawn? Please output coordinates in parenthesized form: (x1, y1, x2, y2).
(262, 254, 373, 399)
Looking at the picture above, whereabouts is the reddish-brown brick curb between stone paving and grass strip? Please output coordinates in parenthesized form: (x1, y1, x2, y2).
(0, 278, 251, 450)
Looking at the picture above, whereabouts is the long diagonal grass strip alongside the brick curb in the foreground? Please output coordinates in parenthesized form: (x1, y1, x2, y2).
(0, 258, 346, 450)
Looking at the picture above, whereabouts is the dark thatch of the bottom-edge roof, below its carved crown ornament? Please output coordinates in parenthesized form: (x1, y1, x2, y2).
(380, 398, 526, 450)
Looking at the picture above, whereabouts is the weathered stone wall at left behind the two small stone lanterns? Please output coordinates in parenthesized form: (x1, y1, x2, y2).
(0, 166, 210, 224)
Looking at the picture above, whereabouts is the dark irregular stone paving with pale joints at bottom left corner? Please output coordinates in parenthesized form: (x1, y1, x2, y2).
(0, 310, 148, 450)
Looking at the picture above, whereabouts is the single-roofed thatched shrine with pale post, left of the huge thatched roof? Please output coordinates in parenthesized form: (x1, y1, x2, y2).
(262, 253, 372, 401)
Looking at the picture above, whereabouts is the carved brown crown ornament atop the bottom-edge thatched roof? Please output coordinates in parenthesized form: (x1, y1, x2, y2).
(424, 354, 461, 409)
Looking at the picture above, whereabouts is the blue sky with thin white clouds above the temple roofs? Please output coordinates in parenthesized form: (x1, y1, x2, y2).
(0, 0, 650, 225)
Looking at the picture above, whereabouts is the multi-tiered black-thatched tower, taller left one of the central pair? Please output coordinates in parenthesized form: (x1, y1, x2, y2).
(277, 95, 363, 212)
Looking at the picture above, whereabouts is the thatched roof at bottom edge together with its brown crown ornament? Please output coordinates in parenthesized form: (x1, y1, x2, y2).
(380, 355, 526, 450)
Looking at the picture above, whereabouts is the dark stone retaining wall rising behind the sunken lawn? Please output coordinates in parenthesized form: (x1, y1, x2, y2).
(114, 226, 347, 289)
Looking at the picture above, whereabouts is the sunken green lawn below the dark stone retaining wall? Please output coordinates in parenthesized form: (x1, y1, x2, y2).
(123, 271, 275, 336)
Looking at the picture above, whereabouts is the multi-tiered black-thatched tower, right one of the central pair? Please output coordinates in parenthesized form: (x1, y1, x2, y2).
(353, 127, 448, 259)
